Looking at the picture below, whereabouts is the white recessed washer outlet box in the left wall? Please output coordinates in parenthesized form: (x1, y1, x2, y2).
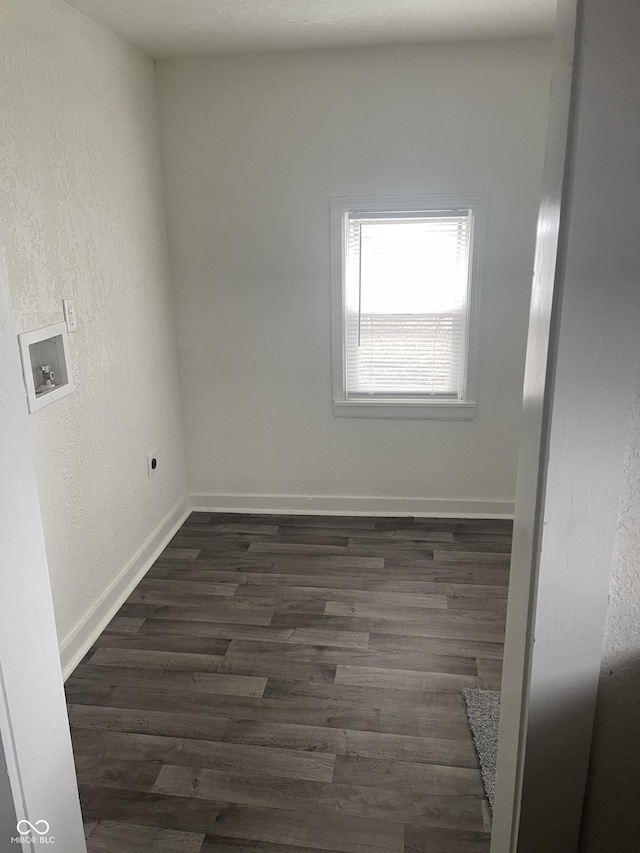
(18, 323, 75, 412)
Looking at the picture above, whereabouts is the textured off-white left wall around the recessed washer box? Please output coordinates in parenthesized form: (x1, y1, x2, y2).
(0, 0, 186, 640)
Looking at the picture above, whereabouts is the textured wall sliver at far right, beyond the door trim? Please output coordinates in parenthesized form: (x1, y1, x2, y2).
(581, 342, 640, 853)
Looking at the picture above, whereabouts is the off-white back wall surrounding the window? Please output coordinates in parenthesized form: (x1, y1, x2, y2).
(158, 40, 551, 510)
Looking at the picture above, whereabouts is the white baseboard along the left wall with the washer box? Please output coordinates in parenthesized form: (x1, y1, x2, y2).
(60, 497, 191, 680)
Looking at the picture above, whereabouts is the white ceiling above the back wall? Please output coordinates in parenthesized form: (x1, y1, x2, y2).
(66, 0, 556, 59)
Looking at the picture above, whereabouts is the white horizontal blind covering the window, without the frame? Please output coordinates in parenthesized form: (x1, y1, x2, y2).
(344, 210, 473, 399)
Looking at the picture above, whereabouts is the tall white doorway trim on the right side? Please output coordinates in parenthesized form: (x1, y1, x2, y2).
(491, 0, 640, 853)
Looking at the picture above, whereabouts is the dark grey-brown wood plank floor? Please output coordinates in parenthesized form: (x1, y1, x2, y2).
(66, 513, 511, 853)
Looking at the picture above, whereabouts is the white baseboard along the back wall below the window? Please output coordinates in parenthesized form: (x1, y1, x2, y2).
(190, 495, 513, 518)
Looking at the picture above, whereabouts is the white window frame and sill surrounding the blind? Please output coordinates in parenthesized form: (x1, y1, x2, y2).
(331, 193, 487, 420)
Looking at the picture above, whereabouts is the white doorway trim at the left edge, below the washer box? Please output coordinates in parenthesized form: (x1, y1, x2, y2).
(0, 247, 86, 853)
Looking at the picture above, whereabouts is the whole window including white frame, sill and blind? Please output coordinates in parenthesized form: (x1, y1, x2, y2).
(332, 196, 483, 419)
